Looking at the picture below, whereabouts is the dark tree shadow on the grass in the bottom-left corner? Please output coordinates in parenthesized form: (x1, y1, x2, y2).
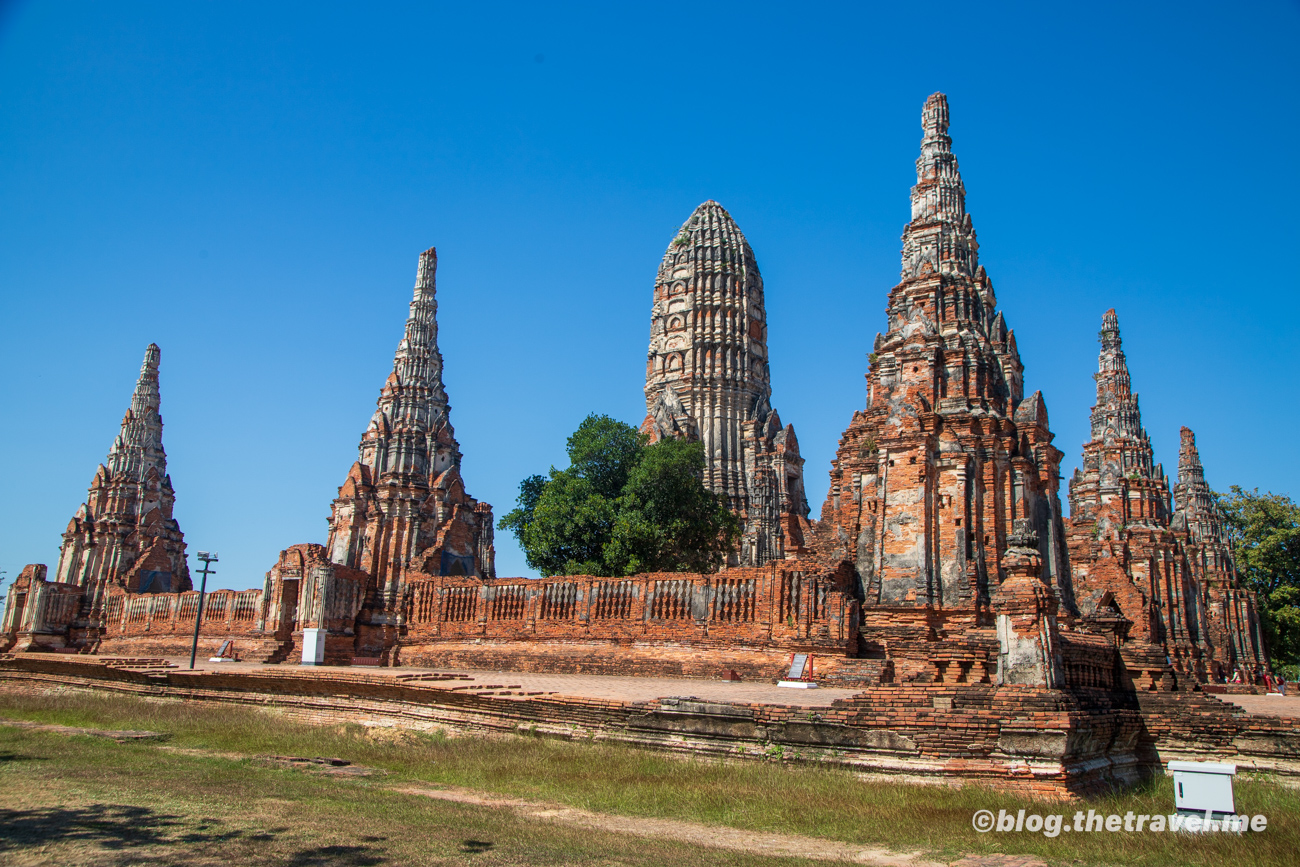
(0, 803, 389, 867)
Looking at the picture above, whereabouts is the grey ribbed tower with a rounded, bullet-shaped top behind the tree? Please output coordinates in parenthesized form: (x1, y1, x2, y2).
(642, 200, 809, 565)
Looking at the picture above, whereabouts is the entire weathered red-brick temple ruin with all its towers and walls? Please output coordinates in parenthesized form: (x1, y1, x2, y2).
(0, 94, 1300, 792)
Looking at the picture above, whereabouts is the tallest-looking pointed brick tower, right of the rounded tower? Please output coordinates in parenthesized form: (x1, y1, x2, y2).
(816, 94, 1074, 613)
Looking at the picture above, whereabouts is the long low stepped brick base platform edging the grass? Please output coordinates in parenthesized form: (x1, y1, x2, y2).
(0, 654, 1300, 798)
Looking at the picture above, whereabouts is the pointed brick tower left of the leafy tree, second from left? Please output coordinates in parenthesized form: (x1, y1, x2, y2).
(326, 248, 494, 610)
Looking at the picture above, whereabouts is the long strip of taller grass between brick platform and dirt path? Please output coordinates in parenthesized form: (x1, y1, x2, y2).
(0, 692, 1300, 866)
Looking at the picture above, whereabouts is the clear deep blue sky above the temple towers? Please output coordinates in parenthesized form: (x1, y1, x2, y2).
(0, 0, 1300, 588)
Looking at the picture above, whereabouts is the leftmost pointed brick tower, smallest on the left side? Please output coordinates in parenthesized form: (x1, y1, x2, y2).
(56, 343, 191, 615)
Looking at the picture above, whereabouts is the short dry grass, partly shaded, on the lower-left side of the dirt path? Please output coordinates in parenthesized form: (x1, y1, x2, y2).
(0, 727, 811, 867)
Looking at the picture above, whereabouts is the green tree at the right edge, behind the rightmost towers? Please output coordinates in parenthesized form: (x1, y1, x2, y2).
(1217, 485, 1300, 667)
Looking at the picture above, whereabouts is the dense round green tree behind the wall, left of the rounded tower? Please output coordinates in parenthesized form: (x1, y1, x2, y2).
(498, 415, 740, 576)
